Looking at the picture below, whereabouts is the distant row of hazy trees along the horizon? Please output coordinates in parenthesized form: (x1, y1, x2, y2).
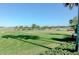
(14, 24, 69, 30)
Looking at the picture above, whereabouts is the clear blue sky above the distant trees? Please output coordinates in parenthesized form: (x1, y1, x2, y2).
(0, 3, 78, 27)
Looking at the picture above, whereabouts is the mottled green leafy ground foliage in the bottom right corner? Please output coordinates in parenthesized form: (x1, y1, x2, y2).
(40, 43, 79, 55)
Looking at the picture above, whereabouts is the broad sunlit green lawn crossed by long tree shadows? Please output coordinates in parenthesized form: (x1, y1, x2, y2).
(0, 30, 74, 55)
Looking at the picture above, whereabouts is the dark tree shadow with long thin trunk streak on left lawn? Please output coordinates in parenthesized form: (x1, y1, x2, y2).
(2, 35, 52, 50)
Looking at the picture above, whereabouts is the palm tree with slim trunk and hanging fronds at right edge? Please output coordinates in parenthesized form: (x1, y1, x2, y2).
(64, 3, 79, 52)
